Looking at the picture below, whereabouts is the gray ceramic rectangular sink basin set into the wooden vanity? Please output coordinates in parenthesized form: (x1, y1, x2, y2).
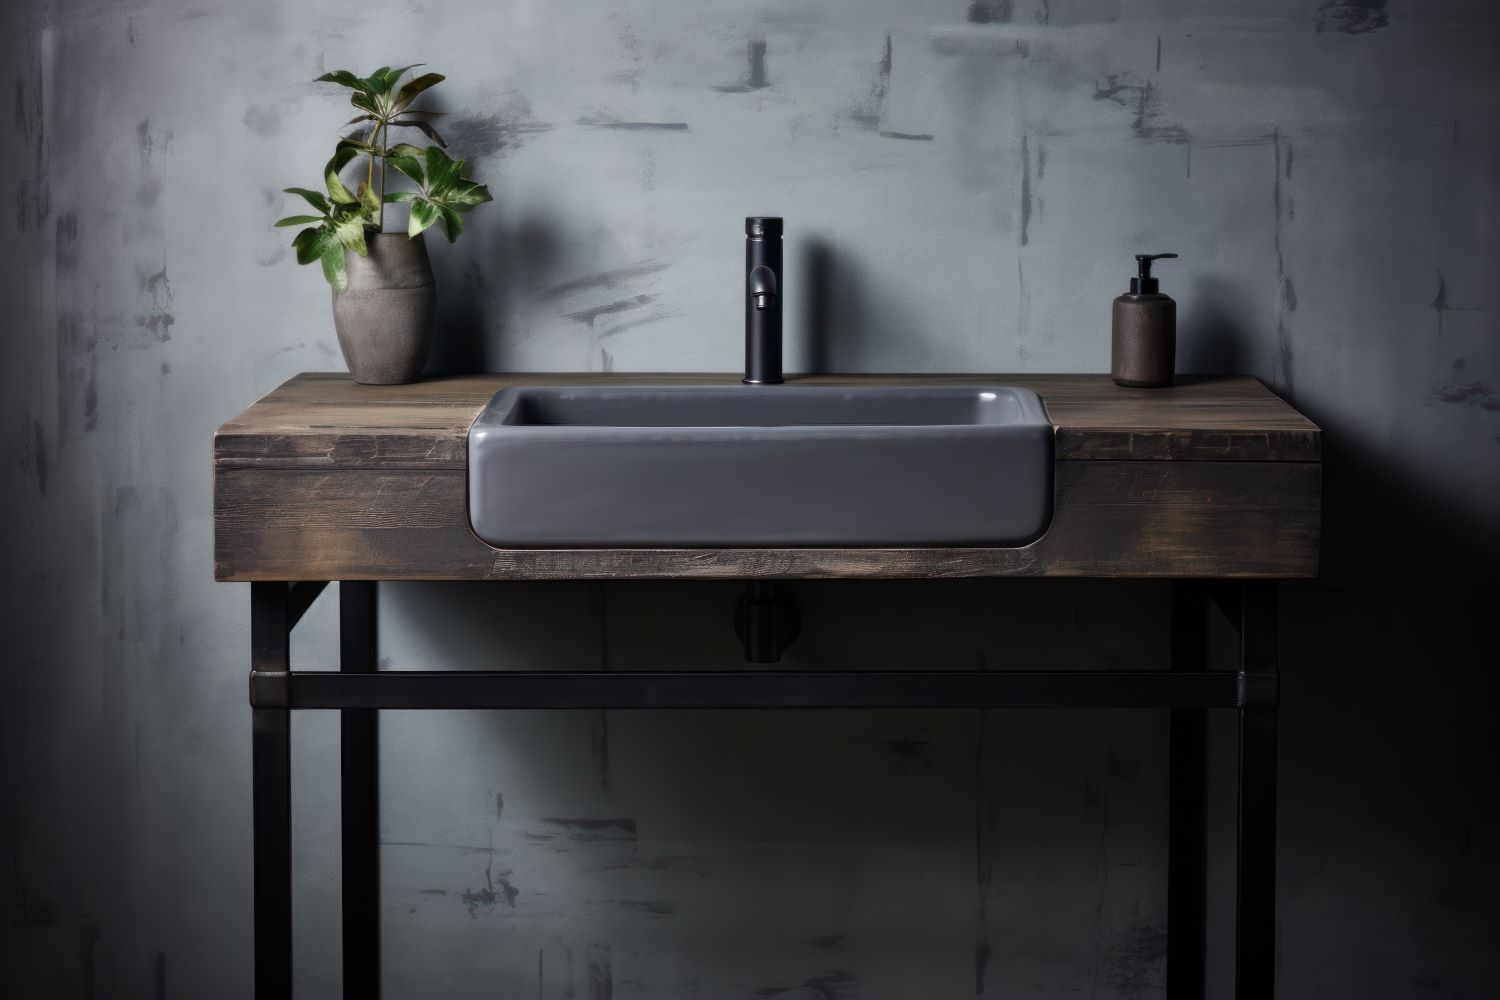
(468, 385, 1052, 549)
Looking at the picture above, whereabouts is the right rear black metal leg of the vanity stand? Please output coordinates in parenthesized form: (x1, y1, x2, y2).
(1167, 580, 1208, 1000)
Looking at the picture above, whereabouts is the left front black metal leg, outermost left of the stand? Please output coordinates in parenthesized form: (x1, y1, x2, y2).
(251, 583, 291, 1000)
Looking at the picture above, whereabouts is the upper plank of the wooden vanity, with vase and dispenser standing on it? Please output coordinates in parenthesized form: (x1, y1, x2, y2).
(215, 372, 1322, 469)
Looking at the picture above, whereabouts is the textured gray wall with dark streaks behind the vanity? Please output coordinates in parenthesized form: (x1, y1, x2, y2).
(0, 0, 1500, 1000)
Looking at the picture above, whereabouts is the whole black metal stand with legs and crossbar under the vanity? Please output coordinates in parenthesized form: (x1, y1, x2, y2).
(251, 580, 1278, 1000)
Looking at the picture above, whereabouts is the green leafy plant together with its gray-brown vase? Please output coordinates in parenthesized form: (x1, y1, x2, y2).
(276, 66, 491, 385)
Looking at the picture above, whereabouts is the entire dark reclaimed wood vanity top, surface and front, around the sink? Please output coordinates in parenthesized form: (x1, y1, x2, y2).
(213, 373, 1322, 580)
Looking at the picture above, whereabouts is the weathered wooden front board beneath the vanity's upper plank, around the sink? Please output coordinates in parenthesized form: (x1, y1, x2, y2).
(215, 460, 1322, 580)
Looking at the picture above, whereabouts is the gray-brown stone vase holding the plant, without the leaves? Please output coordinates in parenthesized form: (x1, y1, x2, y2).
(333, 232, 438, 385)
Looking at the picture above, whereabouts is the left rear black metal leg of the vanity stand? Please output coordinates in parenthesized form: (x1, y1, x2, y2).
(339, 580, 380, 1000)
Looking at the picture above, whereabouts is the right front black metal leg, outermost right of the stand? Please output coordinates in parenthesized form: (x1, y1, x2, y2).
(1235, 582, 1278, 1000)
